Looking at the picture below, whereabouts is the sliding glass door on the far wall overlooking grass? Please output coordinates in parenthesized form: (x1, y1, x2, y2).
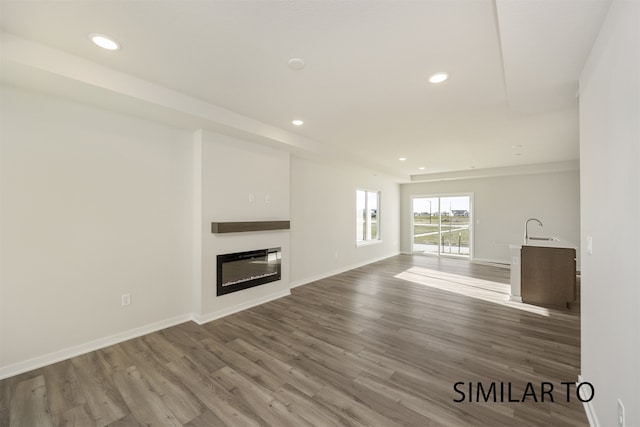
(411, 195, 472, 258)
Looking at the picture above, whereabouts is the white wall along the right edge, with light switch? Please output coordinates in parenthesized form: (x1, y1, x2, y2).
(580, 0, 640, 426)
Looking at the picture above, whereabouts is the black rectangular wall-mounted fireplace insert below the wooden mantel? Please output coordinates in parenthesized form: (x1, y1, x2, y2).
(217, 248, 282, 296)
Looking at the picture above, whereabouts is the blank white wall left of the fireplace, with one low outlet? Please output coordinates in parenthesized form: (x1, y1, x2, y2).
(0, 86, 192, 368)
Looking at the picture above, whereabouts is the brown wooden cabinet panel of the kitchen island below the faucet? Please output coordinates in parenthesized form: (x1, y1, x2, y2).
(520, 246, 576, 307)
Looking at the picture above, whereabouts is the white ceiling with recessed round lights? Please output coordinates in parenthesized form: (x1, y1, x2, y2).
(0, 0, 610, 179)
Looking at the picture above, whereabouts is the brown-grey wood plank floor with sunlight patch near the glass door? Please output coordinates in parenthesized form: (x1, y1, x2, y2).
(0, 255, 588, 427)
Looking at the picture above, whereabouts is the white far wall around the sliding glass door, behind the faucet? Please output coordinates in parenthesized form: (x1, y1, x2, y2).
(402, 171, 580, 263)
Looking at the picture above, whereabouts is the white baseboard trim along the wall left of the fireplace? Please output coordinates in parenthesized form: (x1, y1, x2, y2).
(0, 314, 193, 380)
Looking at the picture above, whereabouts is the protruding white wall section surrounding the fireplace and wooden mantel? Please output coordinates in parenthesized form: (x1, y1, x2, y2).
(194, 131, 290, 321)
